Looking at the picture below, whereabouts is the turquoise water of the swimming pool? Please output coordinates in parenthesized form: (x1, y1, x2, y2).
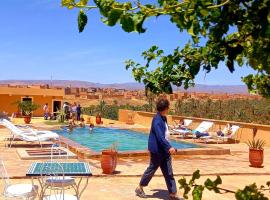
(55, 127, 199, 152)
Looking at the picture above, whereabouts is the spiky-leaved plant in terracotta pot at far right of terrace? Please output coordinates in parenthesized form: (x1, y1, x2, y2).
(247, 139, 265, 167)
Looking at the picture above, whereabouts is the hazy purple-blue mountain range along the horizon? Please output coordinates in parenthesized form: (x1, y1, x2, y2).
(0, 80, 248, 94)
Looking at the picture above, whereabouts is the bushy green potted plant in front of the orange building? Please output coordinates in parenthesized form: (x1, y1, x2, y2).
(17, 101, 39, 124)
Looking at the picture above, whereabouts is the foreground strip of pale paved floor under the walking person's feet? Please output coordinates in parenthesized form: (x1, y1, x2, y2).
(0, 175, 270, 200)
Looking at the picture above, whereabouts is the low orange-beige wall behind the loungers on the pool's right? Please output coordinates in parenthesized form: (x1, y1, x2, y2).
(119, 110, 270, 146)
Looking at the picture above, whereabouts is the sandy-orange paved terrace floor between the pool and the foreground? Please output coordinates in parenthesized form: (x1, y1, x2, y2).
(0, 118, 270, 200)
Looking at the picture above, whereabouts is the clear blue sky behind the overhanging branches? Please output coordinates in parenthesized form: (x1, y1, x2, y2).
(0, 0, 255, 85)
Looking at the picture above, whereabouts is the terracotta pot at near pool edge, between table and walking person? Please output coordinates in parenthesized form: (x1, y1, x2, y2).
(101, 143, 117, 174)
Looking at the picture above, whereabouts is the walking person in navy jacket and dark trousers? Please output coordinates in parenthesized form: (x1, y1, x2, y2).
(135, 98, 180, 200)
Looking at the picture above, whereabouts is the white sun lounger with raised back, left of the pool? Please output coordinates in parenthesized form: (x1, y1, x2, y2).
(0, 119, 59, 147)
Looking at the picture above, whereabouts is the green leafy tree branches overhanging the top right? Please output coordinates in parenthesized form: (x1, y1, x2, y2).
(62, 0, 270, 97)
